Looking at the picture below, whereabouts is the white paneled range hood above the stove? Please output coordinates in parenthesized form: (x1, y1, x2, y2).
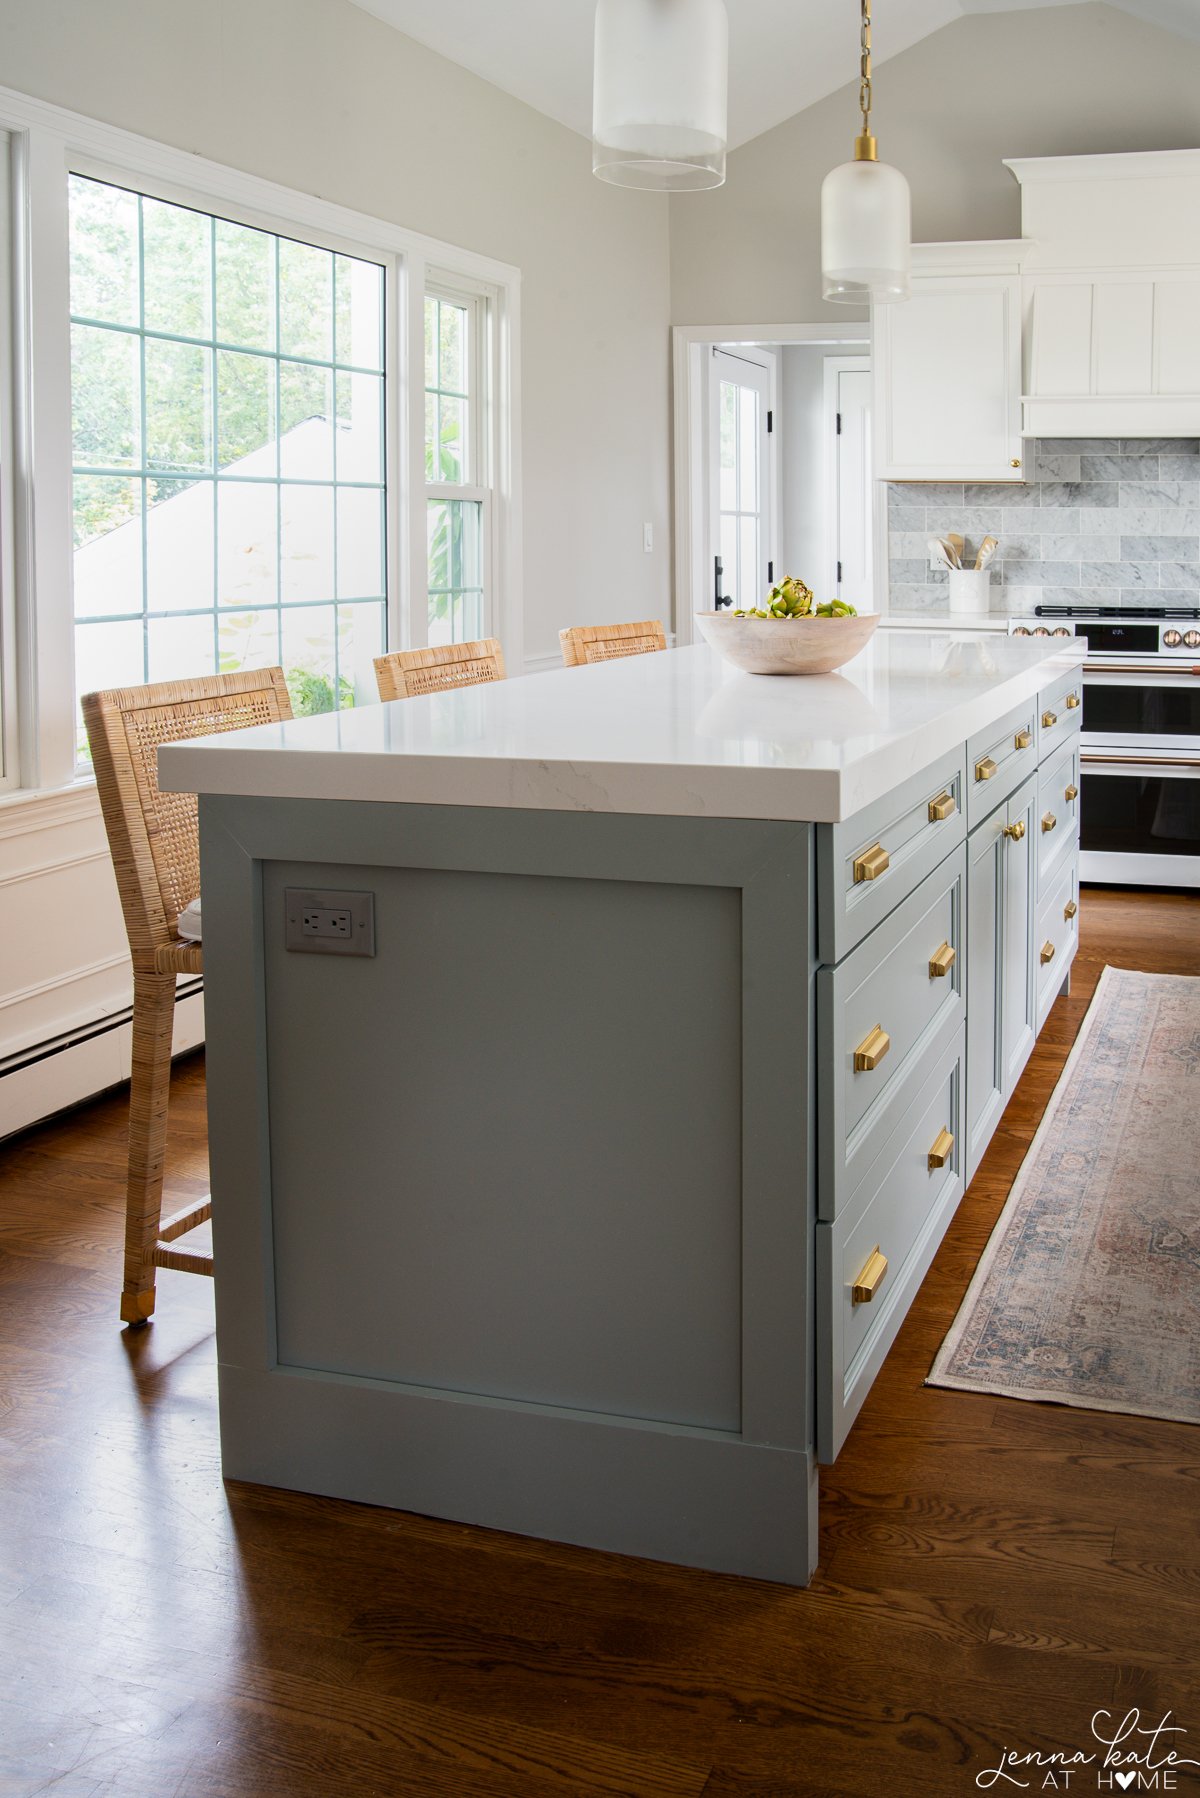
(1007, 149, 1200, 437)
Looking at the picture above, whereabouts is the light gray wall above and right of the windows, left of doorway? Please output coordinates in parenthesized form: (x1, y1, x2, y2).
(0, 0, 669, 672)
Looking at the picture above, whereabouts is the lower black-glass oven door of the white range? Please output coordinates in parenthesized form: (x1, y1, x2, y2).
(1079, 744, 1200, 886)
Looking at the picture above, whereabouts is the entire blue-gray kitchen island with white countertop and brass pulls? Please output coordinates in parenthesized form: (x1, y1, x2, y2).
(160, 633, 1081, 1584)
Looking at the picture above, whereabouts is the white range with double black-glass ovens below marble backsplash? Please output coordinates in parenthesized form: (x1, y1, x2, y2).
(1009, 604, 1200, 886)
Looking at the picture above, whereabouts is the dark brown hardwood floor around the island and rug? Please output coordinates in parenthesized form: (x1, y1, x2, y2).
(0, 890, 1200, 1798)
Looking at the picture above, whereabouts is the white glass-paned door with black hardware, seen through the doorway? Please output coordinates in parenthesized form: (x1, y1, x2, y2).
(709, 349, 775, 610)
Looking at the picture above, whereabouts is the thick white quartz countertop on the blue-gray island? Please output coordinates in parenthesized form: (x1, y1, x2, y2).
(158, 631, 1083, 823)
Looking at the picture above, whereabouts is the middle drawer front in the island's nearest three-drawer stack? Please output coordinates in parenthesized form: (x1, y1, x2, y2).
(817, 845, 966, 1215)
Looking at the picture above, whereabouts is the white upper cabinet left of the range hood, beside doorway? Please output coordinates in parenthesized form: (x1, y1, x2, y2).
(873, 243, 1025, 482)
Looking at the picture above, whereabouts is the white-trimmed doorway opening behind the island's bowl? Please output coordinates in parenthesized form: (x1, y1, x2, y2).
(675, 324, 885, 644)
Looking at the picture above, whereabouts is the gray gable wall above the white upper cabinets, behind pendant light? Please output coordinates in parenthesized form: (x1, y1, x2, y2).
(671, 4, 1200, 324)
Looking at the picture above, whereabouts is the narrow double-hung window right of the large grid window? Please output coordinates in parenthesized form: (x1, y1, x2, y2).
(425, 280, 497, 645)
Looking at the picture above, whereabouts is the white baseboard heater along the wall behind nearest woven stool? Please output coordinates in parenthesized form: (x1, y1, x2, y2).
(0, 987, 203, 1138)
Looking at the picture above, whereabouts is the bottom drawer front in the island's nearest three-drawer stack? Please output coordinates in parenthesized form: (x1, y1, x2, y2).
(817, 1030, 963, 1462)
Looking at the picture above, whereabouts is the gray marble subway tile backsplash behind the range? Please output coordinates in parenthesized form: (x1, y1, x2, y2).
(887, 437, 1200, 613)
